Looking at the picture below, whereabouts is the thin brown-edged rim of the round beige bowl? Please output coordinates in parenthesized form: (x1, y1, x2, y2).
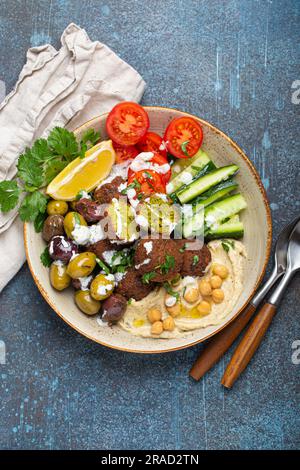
(24, 106, 272, 354)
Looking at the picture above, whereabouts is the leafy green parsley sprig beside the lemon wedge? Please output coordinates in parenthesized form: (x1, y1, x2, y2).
(0, 127, 100, 231)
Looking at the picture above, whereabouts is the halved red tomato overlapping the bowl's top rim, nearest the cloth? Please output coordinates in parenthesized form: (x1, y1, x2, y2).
(106, 101, 149, 147)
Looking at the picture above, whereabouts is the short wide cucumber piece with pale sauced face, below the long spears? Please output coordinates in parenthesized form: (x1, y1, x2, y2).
(205, 194, 247, 230)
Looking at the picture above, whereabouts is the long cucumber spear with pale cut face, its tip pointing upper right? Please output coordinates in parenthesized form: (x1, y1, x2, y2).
(176, 165, 239, 204)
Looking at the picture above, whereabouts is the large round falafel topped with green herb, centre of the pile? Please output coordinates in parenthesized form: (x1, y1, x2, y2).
(134, 239, 183, 282)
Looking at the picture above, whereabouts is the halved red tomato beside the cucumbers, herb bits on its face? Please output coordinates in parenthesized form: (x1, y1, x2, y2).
(164, 116, 203, 158)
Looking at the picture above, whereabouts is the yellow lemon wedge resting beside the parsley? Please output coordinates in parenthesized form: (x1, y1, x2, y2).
(47, 140, 116, 201)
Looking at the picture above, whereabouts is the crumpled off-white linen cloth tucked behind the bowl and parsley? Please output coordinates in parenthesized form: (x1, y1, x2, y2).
(0, 23, 145, 292)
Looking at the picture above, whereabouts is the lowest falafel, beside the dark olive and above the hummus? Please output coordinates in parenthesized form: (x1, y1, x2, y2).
(115, 268, 155, 300)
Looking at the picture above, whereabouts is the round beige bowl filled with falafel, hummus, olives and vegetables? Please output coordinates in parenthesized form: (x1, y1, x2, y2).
(25, 102, 271, 352)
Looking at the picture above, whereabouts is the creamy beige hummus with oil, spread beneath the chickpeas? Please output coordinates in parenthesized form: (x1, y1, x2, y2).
(119, 239, 246, 338)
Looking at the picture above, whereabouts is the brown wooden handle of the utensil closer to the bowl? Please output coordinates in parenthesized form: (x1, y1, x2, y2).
(189, 303, 256, 380)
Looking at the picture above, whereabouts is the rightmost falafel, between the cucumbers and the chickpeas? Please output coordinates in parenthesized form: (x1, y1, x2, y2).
(177, 240, 211, 277)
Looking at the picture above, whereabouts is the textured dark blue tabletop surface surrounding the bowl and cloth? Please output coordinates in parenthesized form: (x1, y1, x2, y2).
(0, 0, 300, 449)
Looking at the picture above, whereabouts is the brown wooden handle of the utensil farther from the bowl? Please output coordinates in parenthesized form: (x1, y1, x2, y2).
(221, 303, 276, 388)
